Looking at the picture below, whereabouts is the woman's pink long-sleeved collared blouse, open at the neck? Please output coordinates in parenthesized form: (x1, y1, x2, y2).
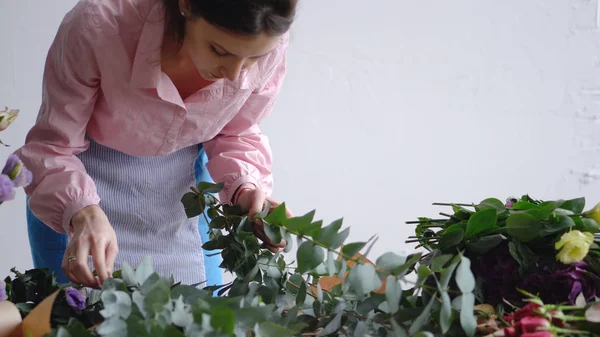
(16, 0, 289, 232)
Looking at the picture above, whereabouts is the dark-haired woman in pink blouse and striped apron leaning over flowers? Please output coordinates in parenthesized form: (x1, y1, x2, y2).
(17, 0, 296, 287)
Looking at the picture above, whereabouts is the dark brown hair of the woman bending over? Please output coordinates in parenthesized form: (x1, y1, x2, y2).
(162, 0, 298, 43)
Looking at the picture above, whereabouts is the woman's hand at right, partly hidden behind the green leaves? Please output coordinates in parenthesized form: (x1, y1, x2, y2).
(237, 185, 293, 253)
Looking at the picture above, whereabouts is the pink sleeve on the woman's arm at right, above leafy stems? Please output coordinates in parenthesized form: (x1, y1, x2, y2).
(204, 40, 287, 203)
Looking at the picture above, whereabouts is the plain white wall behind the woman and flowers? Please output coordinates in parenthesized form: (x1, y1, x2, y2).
(0, 0, 600, 276)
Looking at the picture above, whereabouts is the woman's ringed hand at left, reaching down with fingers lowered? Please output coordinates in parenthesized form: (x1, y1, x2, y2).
(62, 206, 118, 288)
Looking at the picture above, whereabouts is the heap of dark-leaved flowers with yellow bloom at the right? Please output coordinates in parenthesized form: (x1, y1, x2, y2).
(407, 195, 600, 337)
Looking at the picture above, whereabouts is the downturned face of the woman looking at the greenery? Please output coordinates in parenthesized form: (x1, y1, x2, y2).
(181, 14, 279, 81)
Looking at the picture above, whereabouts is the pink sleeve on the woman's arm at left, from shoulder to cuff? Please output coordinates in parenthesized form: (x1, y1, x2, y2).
(16, 1, 100, 232)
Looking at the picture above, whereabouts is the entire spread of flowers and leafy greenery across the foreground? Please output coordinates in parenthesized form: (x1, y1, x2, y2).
(0, 103, 600, 337)
